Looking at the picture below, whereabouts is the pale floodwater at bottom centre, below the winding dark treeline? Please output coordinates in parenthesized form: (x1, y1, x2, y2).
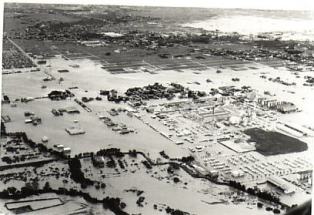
(105, 168, 268, 215)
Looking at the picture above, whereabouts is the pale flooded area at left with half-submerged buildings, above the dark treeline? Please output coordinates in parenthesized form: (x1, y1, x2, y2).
(3, 99, 186, 157)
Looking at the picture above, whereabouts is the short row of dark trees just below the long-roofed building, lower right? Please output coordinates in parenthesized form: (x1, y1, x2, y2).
(229, 181, 280, 204)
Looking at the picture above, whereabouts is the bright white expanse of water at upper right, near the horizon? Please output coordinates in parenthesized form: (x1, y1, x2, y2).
(183, 14, 314, 41)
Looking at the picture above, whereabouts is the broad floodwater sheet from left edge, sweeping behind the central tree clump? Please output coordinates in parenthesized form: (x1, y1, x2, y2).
(3, 54, 314, 158)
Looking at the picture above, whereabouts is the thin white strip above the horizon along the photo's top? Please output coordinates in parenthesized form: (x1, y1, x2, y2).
(3, 0, 314, 12)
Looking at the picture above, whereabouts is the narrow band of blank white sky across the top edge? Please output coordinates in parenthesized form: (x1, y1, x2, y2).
(4, 0, 314, 11)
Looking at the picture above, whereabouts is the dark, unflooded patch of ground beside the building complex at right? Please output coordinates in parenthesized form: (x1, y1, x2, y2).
(244, 128, 308, 156)
